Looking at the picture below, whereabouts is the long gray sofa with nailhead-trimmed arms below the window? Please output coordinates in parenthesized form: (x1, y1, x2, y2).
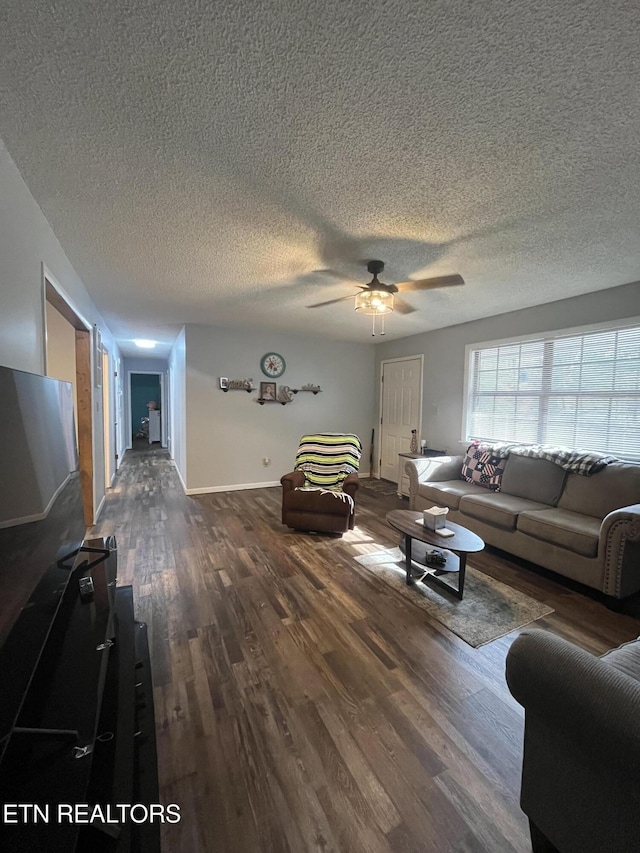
(405, 455, 640, 599)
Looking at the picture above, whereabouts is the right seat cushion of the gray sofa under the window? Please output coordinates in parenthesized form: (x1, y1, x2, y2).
(518, 510, 602, 557)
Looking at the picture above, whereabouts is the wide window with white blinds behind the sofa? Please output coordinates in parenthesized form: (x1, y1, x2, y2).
(464, 322, 640, 459)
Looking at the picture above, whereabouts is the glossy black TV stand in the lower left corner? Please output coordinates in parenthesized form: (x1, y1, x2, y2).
(0, 537, 160, 853)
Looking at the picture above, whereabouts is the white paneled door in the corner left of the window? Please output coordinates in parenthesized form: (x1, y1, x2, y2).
(380, 357, 422, 483)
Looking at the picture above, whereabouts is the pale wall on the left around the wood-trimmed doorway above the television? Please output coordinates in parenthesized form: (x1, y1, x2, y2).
(0, 141, 118, 520)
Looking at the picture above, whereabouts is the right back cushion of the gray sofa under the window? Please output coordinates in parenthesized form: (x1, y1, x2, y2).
(558, 462, 640, 519)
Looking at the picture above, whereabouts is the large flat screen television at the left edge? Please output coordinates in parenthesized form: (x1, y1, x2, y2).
(0, 367, 85, 756)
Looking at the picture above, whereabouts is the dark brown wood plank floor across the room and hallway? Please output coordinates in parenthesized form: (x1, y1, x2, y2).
(94, 445, 639, 853)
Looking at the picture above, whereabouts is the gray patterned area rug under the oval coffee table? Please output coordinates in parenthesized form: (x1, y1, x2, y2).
(355, 548, 553, 648)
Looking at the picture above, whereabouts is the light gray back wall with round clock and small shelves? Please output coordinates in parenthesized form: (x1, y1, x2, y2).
(186, 325, 375, 491)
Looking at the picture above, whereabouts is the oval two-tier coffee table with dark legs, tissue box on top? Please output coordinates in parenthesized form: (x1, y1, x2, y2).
(387, 509, 484, 599)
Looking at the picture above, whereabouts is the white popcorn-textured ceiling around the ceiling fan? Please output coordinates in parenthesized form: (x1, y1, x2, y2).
(0, 0, 640, 352)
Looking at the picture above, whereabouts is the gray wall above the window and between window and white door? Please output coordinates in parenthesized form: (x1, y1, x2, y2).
(376, 283, 640, 453)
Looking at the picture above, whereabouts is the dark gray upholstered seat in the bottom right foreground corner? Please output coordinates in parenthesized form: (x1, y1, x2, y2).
(507, 630, 640, 853)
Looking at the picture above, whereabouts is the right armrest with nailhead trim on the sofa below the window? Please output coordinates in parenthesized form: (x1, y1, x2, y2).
(598, 504, 640, 598)
